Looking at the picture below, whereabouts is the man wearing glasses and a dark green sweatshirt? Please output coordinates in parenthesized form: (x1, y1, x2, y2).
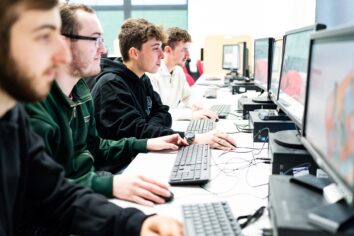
(26, 4, 186, 206)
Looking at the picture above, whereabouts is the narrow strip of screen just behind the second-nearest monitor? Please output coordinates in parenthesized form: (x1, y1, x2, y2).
(269, 39, 283, 101)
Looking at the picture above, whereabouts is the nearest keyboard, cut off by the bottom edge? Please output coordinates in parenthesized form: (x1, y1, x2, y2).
(182, 202, 242, 236)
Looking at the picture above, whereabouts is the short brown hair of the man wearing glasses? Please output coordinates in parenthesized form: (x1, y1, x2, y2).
(60, 3, 95, 35)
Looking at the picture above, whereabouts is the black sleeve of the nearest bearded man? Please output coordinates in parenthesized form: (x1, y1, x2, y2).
(23, 126, 146, 236)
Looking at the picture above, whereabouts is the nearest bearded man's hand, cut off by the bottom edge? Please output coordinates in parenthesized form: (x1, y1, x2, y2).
(140, 215, 184, 236)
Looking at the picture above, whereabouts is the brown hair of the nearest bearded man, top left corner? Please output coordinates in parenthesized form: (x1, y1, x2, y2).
(0, 0, 58, 74)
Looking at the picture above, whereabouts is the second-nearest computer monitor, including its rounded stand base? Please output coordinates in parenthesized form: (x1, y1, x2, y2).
(274, 24, 326, 148)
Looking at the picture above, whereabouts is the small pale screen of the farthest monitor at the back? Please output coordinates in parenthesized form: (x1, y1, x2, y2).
(222, 44, 240, 70)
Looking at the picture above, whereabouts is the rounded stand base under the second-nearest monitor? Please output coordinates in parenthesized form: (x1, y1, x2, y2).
(274, 130, 305, 149)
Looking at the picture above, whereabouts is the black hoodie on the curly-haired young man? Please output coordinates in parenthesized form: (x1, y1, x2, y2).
(92, 58, 183, 140)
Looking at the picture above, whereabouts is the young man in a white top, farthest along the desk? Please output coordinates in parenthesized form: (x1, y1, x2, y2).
(146, 27, 218, 120)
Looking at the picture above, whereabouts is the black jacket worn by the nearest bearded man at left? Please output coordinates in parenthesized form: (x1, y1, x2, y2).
(0, 105, 146, 236)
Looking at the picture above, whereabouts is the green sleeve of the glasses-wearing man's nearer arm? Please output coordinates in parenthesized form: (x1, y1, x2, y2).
(25, 103, 113, 197)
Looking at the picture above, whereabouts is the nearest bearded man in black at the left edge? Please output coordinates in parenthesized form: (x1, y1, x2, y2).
(0, 0, 182, 236)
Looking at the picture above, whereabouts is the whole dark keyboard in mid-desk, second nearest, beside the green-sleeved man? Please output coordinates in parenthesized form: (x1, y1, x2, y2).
(169, 144, 211, 185)
